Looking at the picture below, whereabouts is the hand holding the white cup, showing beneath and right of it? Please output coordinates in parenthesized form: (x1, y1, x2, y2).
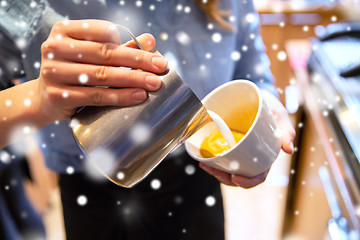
(200, 90, 295, 188)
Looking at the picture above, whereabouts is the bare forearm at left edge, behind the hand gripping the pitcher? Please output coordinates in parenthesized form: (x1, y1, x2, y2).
(0, 80, 51, 148)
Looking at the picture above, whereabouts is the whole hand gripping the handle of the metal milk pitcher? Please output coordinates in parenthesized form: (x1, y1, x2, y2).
(37, 20, 167, 122)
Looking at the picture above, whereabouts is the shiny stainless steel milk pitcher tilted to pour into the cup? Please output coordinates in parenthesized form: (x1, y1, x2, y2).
(71, 70, 211, 187)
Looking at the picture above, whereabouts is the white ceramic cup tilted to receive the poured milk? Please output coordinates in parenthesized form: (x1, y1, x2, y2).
(185, 80, 281, 177)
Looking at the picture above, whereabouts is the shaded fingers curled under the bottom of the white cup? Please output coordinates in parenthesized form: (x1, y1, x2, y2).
(199, 163, 269, 188)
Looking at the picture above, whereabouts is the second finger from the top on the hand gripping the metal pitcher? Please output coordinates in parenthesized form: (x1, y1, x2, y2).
(42, 38, 168, 74)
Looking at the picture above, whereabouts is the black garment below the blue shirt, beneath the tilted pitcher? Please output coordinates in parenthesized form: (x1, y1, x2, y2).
(60, 150, 224, 240)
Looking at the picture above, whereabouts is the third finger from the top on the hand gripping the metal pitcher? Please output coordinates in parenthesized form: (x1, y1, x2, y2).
(41, 61, 161, 91)
